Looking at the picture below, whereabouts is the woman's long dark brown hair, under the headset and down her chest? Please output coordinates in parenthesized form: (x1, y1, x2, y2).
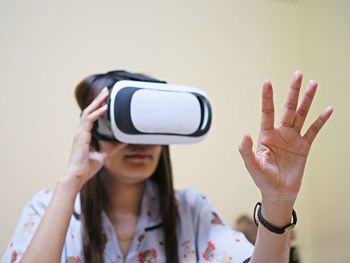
(75, 71, 179, 263)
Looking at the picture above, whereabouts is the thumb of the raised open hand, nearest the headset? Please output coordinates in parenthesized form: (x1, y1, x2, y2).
(239, 135, 260, 175)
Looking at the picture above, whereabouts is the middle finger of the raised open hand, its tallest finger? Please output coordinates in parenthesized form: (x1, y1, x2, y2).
(281, 71, 303, 127)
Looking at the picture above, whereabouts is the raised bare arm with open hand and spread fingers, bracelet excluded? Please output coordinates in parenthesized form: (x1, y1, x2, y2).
(239, 72, 333, 263)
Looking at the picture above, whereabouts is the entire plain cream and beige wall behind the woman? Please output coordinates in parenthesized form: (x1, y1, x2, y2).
(0, 0, 350, 263)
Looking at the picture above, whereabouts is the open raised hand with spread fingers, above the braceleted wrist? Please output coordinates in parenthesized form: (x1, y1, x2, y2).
(240, 72, 332, 201)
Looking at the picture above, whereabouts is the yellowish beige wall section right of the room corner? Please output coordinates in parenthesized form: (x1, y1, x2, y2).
(298, 0, 350, 263)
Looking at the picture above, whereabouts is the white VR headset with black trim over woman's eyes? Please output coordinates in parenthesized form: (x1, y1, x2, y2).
(93, 80, 212, 145)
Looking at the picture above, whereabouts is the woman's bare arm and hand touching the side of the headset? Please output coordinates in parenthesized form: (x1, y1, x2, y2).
(21, 89, 123, 263)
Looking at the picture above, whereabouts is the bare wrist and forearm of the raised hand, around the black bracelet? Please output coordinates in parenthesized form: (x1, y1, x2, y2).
(250, 199, 294, 263)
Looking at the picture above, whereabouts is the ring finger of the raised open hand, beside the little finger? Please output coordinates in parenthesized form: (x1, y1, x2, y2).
(292, 80, 317, 132)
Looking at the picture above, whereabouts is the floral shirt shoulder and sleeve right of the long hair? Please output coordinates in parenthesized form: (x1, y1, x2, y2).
(176, 189, 253, 262)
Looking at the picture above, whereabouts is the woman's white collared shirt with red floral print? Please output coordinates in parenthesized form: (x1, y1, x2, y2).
(1, 181, 253, 263)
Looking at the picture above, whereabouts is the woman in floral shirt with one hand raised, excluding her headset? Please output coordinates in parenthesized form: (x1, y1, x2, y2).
(3, 71, 333, 263)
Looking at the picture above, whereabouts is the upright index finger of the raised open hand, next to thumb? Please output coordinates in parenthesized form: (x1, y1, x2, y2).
(260, 81, 275, 131)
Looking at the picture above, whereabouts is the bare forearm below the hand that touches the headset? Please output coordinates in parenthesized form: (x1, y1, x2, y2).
(21, 179, 78, 263)
